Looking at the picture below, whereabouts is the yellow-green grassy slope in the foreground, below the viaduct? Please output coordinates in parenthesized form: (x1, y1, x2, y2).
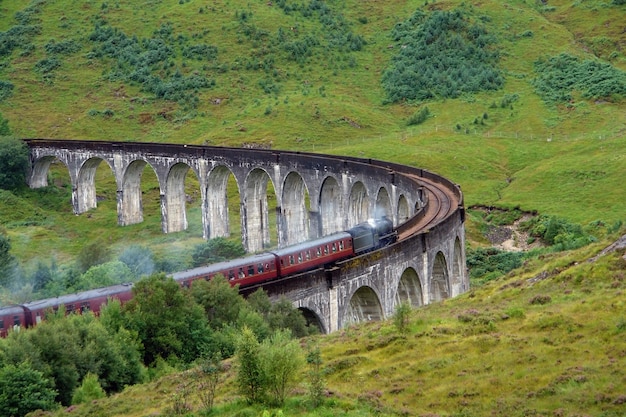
(33, 234, 626, 417)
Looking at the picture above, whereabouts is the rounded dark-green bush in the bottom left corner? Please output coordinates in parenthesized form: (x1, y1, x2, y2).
(0, 363, 56, 417)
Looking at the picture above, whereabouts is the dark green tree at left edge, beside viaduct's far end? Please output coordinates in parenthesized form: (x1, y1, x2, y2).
(0, 136, 30, 190)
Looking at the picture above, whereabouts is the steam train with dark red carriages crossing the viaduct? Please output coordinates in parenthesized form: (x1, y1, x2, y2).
(0, 217, 397, 337)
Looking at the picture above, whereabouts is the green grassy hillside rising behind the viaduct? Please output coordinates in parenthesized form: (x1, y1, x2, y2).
(0, 0, 626, 266)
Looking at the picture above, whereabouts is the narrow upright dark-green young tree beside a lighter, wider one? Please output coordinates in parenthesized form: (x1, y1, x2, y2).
(235, 327, 265, 404)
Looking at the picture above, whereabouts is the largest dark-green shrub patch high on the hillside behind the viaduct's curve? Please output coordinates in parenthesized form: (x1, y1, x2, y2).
(382, 10, 504, 103)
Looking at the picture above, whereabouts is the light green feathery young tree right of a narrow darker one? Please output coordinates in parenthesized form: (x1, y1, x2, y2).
(261, 330, 304, 405)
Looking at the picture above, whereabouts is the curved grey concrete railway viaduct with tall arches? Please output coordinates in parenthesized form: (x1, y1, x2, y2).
(26, 139, 469, 332)
